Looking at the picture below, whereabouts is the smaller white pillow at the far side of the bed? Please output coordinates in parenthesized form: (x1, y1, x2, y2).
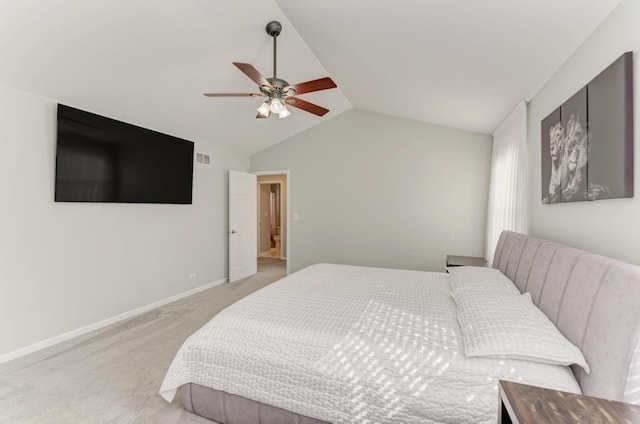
(447, 266, 520, 295)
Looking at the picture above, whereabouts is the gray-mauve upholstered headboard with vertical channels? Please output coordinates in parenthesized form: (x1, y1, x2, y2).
(493, 231, 640, 404)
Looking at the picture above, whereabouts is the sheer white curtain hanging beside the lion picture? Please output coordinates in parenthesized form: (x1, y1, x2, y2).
(485, 101, 528, 264)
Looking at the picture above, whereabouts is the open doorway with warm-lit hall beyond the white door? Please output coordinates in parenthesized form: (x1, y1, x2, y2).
(256, 171, 289, 274)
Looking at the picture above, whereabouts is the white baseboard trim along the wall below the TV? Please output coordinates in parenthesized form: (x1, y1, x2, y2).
(0, 278, 229, 364)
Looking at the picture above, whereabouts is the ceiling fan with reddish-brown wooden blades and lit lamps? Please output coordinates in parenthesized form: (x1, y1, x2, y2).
(204, 21, 337, 118)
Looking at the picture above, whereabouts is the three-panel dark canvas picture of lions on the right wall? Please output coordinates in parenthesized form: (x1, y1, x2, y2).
(541, 52, 633, 203)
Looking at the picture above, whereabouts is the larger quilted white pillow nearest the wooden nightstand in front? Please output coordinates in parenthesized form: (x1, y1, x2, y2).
(454, 290, 589, 374)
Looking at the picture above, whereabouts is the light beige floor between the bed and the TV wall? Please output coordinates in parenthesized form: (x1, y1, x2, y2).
(0, 258, 285, 424)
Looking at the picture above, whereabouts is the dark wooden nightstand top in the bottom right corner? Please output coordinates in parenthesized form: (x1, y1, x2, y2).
(498, 380, 640, 424)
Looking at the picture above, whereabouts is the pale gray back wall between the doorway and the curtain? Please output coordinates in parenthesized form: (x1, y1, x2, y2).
(251, 110, 492, 271)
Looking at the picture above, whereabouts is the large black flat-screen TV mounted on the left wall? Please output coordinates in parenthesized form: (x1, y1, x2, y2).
(55, 105, 194, 204)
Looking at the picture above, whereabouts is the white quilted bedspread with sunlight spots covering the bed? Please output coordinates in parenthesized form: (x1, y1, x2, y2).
(160, 264, 580, 424)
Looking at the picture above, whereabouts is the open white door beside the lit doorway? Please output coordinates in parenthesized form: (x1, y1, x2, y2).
(229, 170, 258, 283)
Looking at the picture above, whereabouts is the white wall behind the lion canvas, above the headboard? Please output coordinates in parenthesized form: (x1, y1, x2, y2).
(528, 0, 640, 264)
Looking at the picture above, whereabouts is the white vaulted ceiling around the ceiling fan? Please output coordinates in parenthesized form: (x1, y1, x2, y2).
(0, 0, 619, 154)
